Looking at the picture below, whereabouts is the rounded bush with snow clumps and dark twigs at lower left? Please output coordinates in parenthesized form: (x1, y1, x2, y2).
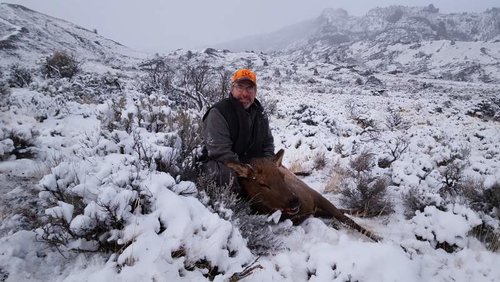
(37, 155, 151, 252)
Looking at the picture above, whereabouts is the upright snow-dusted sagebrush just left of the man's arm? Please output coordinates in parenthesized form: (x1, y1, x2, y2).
(98, 94, 201, 181)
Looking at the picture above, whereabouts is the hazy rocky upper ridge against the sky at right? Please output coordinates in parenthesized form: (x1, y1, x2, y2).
(217, 5, 500, 51)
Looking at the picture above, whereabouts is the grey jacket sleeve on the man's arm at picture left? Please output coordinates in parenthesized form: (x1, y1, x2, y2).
(202, 108, 239, 162)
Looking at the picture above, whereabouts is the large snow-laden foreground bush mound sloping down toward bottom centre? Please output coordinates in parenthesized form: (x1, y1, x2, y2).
(36, 154, 252, 279)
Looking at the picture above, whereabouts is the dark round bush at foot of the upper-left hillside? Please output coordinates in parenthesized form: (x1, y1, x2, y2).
(41, 50, 80, 79)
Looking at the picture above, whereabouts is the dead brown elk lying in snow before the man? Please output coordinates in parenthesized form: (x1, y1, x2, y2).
(226, 149, 380, 242)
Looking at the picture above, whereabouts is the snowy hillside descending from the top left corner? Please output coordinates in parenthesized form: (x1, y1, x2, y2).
(0, 3, 145, 67)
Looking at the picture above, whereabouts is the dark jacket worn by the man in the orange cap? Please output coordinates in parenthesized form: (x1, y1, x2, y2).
(203, 96, 274, 162)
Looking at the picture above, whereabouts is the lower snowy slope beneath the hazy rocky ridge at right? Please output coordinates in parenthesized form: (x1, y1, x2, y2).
(291, 40, 500, 83)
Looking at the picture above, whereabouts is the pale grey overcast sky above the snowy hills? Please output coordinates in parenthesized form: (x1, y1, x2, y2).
(0, 0, 500, 52)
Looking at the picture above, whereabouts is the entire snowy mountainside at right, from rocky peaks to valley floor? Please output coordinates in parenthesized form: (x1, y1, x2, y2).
(216, 5, 500, 83)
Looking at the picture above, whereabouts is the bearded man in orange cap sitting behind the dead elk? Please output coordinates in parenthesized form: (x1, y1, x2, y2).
(202, 69, 274, 192)
